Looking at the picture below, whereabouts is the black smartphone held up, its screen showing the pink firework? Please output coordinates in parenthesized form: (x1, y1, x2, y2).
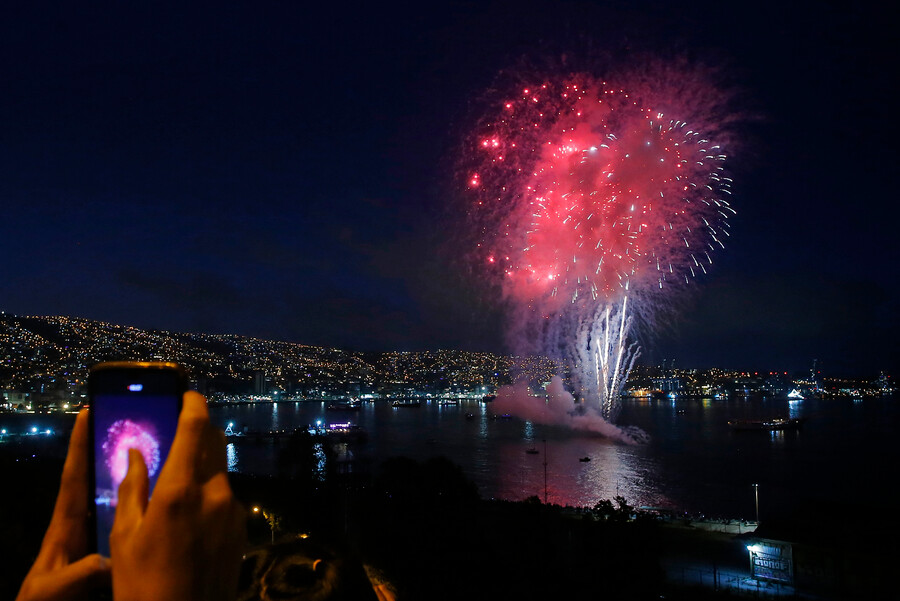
(88, 361, 187, 557)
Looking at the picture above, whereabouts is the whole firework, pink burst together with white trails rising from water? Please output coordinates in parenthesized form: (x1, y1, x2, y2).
(466, 62, 734, 432)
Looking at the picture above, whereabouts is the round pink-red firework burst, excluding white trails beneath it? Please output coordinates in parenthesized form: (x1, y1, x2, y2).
(467, 74, 734, 311)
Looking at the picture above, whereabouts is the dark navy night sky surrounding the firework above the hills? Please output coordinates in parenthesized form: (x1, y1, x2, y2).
(0, 0, 900, 375)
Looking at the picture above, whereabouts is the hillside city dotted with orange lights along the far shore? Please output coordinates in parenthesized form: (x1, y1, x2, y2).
(0, 313, 895, 400)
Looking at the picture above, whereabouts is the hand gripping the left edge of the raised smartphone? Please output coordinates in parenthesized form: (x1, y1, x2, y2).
(16, 410, 110, 601)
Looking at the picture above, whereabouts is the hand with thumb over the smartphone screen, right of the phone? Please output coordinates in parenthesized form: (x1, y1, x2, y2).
(110, 392, 247, 601)
